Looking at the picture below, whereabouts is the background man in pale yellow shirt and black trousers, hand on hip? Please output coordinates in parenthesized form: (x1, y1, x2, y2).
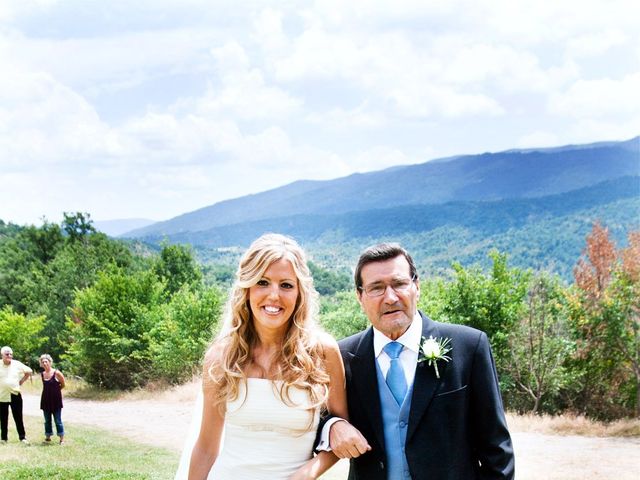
(0, 347, 33, 443)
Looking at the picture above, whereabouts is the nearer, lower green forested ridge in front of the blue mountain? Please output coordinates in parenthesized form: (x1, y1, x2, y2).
(147, 177, 640, 280)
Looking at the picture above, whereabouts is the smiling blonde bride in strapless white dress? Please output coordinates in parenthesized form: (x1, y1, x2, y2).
(188, 234, 356, 480)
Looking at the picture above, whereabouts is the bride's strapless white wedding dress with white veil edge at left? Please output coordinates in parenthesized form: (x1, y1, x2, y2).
(175, 378, 319, 480)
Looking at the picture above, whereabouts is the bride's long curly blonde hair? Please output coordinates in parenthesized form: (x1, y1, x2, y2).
(204, 233, 329, 416)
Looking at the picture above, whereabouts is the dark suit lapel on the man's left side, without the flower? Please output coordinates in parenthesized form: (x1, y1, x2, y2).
(349, 328, 384, 452)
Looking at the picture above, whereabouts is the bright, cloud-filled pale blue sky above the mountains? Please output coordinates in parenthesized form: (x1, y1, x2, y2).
(0, 0, 640, 224)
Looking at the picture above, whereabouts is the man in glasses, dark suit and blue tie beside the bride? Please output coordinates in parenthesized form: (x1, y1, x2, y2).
(329, 244, 514, 480)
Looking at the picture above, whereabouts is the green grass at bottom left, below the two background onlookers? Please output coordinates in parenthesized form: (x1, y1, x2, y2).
(0, 416, 179, 480)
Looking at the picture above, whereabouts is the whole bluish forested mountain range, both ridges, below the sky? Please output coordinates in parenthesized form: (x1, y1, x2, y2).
(124, 137, 640, 276)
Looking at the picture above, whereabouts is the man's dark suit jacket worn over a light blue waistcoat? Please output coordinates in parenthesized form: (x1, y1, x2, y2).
(338, 313, 514, 480)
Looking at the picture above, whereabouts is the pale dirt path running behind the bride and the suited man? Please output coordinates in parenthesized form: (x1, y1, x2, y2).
(24, 388, 640, 480)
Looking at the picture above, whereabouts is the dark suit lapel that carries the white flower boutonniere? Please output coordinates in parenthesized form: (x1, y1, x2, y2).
(407, 313, 446, 441)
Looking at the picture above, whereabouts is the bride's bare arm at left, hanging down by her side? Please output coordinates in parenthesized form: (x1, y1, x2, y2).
(189, 349, 224, 480)
